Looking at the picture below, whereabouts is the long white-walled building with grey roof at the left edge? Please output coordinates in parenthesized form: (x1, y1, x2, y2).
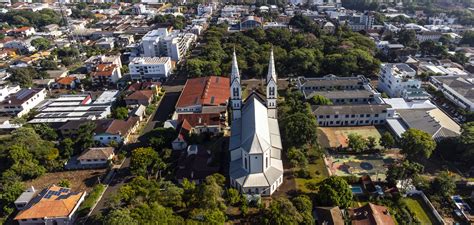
(0, 88, 47, 117)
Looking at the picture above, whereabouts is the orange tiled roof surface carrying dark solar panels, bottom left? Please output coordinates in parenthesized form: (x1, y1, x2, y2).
(15, 185, 86, 220)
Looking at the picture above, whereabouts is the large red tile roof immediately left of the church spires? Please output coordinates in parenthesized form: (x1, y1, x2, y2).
(176, 76, 230, 108)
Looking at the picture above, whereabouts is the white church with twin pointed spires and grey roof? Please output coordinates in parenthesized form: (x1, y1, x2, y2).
(229, 49, 283, 196)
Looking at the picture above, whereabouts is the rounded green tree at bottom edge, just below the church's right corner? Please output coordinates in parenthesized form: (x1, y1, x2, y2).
(261, 197, 303, 225)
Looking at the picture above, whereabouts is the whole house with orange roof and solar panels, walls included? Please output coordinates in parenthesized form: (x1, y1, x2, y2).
(14, 185, 86, 225)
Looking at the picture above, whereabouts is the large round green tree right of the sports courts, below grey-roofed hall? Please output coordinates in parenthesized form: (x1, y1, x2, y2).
(400, 128, 436, 158)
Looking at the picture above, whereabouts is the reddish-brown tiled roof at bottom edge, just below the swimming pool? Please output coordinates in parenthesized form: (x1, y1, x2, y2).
(349, 203, 395, 225)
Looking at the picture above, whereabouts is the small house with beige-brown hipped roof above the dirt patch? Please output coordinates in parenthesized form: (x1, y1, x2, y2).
(77, 147, 114, 166)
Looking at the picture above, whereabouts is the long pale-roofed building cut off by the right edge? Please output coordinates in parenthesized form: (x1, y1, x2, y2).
(430, 76, 474, 112)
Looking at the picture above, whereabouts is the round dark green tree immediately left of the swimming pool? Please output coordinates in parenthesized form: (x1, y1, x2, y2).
(317, 176, 352, 208)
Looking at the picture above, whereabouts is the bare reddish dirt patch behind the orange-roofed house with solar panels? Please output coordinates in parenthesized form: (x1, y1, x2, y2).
(25, 169, 106, 192)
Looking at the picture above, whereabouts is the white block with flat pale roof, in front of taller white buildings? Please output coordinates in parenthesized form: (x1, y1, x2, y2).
(128, 57, 172, 81)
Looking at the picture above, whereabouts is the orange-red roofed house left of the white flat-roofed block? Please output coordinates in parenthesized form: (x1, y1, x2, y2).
(91, 64, 122, 85)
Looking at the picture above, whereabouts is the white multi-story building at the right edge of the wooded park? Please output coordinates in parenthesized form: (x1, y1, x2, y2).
(378, 63, 421, 98)
